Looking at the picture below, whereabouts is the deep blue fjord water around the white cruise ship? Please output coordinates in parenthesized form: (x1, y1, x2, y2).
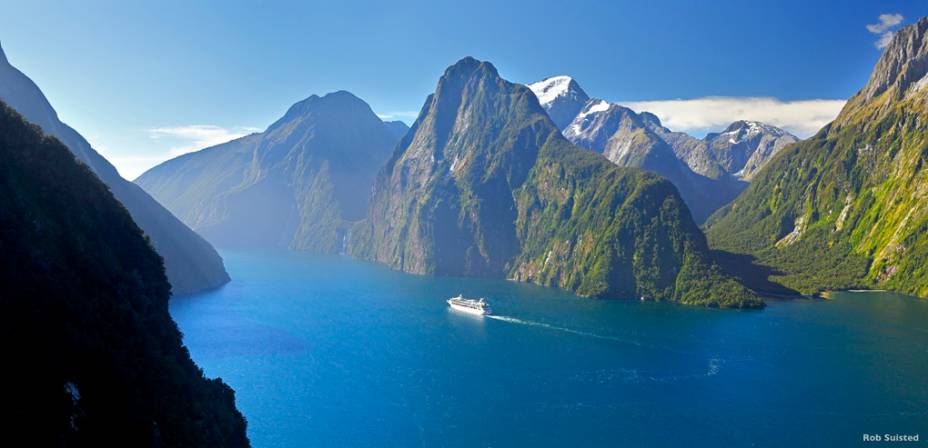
(171, 252, 928, 447)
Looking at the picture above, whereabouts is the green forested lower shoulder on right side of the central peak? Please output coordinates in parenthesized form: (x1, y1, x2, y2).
(509, 138, 761, 308)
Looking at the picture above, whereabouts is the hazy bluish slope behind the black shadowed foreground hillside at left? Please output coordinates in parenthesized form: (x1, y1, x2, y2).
(0, 41, 229, 294)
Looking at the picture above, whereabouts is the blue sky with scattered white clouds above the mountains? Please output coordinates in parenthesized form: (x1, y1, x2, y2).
(0, 0, 928, 179)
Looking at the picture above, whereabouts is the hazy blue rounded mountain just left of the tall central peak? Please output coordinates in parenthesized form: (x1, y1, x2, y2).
(135, 91, 405, 253)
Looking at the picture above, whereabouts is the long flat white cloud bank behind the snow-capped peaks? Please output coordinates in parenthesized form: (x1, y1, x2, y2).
(619, 97, 845, 138)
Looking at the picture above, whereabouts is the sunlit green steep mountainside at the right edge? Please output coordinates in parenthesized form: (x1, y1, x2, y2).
(708, 18, 928, 297)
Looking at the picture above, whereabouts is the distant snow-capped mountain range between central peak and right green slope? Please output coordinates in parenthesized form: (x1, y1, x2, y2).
(529, 76, 798, 222)
